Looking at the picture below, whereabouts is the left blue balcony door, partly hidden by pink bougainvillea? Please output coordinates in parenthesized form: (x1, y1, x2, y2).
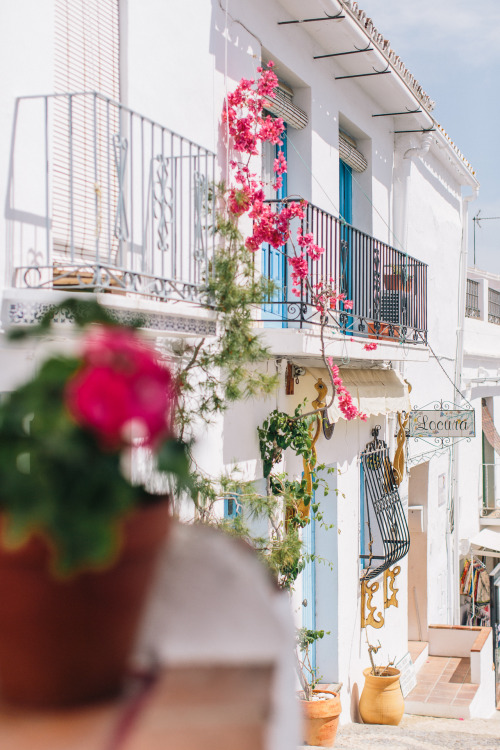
(262, 124, 288, 328)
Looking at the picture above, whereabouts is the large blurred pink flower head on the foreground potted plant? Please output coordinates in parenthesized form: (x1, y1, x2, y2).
(65, 326, 176, 449)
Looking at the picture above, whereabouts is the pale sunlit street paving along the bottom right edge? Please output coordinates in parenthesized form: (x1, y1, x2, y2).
(304, 712, 500, 750)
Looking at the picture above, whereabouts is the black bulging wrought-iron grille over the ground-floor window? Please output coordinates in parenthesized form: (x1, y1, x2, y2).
(360, 428, 410, 581)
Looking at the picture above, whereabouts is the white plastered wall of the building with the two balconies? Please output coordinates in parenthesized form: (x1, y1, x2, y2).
(0, 0, 484, 719)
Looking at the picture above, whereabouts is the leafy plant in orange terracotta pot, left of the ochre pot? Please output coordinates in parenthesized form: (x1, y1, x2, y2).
(297, 628, 342, 747)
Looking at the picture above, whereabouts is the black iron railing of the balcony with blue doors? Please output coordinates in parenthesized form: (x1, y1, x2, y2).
(262, 201, 427, 343)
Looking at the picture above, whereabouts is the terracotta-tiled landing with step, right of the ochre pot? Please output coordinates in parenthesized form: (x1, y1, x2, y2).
(406, 656, 478, 706)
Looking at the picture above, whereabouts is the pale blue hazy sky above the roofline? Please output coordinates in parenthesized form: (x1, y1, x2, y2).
(359, 0, 500, 274)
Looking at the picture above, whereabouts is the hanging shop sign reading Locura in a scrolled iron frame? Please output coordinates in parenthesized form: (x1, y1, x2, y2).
(408, 409, 476, 438)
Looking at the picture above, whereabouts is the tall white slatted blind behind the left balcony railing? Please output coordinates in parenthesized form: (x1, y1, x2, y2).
(52, 0, 119, 263)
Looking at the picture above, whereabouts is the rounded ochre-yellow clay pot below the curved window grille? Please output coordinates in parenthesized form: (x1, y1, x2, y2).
(359, 667, 405, 726)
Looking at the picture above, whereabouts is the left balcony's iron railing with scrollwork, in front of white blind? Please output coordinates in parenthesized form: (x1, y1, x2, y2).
(7, 92, 215, 301)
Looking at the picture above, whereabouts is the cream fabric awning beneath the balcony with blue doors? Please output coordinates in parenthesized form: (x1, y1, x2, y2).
(308, 368, 411, 422)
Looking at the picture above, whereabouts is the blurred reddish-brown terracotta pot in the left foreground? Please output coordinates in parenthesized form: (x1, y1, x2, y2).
(0, 499, 170, 707)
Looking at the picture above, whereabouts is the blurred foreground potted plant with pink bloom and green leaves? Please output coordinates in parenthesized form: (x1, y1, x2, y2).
(0, 301, 188, 706)
